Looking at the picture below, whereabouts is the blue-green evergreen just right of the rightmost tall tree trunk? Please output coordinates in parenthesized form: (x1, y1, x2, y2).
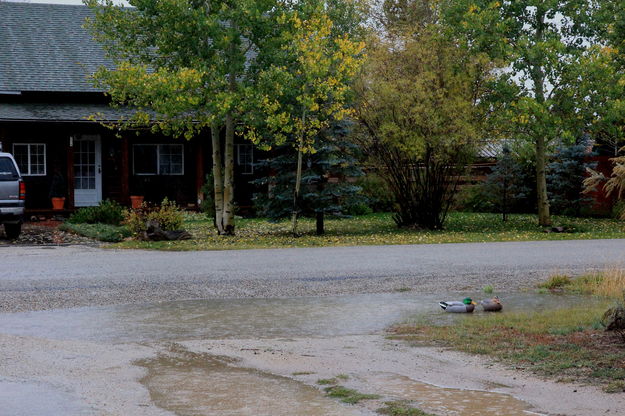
(547, 141, 597, 216)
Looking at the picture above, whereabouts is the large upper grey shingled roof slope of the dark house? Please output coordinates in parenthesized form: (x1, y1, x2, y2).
(0, 2, 112, 92)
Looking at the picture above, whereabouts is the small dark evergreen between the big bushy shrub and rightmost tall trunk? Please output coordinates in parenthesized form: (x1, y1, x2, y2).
(484, 147, 531, 221)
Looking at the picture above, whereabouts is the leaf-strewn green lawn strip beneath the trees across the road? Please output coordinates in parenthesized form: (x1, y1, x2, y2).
(111, 213, 625, 250)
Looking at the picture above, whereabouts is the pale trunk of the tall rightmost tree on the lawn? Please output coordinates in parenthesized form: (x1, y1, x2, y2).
(532, 6, 551, 227)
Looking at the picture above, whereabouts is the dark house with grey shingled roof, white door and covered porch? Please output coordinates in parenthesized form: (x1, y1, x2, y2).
(0, 2, 255, 213)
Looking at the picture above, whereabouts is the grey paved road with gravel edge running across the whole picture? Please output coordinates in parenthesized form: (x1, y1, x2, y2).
(0, 240, 625, 311)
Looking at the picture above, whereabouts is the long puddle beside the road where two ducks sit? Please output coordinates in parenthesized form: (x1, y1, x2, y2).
(0, 292, 597, 342)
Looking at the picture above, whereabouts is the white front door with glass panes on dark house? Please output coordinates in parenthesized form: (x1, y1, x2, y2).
(74, 134, 102, 207)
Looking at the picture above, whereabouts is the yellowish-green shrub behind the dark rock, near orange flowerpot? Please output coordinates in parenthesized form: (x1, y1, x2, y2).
(124, 198, 184, 235)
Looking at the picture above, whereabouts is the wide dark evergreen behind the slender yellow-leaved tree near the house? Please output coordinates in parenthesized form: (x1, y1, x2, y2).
(254, 121, 364, 235)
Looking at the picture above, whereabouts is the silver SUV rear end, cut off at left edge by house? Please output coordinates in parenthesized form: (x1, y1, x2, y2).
(0, 152, 26, 239)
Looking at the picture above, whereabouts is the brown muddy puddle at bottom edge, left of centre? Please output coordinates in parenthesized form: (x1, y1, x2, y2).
(139, 344, 362, 416)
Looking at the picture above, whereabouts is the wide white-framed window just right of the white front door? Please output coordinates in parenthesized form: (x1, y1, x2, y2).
(132, 144, 184, 175)
